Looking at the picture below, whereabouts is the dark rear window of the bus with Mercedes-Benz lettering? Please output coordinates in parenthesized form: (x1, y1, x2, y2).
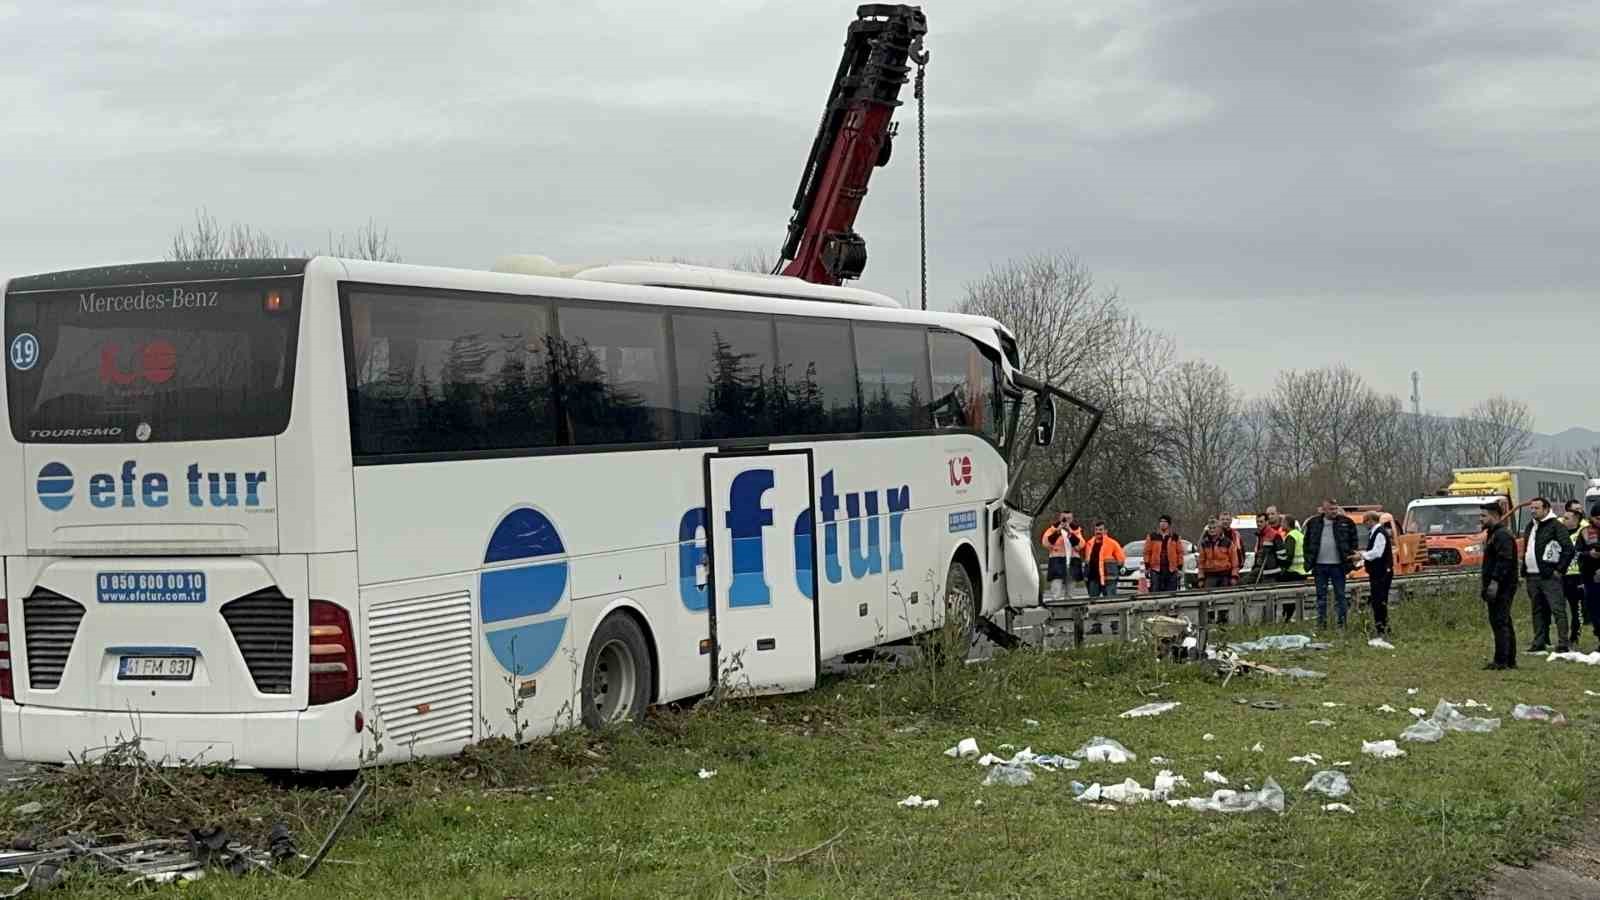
(5, 279, 301, 444)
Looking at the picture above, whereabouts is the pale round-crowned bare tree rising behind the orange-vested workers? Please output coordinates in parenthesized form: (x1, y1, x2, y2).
(1155, 362, 1250, 524)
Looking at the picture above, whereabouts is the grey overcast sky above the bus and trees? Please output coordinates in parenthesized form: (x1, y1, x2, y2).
(0, 0, 1600, 431)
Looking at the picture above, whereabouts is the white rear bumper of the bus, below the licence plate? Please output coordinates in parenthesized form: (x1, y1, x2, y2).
(0, 697, 365, 772)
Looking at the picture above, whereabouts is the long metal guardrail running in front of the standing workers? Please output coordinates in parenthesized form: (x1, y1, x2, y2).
(1005, 567, 1478, 649)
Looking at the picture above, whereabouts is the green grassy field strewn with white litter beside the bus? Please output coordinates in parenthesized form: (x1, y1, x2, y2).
(3, 586, 1600, 900)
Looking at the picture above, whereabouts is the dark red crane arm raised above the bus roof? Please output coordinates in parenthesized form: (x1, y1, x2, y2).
(778, 3, 928, 285)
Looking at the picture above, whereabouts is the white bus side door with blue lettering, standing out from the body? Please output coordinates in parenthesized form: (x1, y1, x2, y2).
(706, 450, 819, 693)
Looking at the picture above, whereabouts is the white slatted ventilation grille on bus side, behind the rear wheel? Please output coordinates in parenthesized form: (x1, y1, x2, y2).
(366, 591, 475, 748)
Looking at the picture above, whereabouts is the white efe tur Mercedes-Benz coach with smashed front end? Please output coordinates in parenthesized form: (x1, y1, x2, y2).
(0, 258, 1086, 770)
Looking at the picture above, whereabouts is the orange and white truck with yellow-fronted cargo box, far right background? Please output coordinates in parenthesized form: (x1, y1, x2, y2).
(1405, 466, 1589, 565)
